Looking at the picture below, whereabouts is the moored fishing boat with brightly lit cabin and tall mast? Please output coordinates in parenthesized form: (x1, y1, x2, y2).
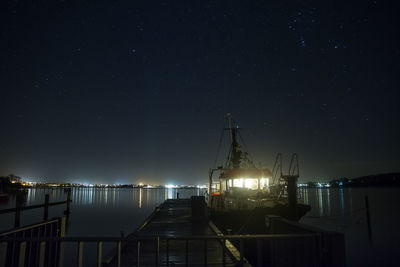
(208, 113, 311, 234)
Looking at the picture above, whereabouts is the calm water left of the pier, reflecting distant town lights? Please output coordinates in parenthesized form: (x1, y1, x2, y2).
(0, 188, 205, 236)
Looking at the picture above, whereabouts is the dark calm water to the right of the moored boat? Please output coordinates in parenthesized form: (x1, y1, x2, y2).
(299, 188, 400, 266)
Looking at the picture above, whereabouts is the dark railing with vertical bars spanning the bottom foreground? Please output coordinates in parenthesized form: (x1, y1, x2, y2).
(0, 229, 342, 267)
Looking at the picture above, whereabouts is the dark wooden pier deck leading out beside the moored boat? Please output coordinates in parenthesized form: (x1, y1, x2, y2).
(104, 199, 237, 266)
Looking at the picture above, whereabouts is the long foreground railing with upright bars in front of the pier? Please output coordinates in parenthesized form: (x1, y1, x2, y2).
(0, 233, 324, 267)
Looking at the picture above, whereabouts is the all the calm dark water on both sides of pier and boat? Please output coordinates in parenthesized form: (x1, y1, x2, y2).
(0, 188, 400, 266)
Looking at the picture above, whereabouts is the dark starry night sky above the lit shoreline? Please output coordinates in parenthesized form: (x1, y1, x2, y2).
(0, 0, 400, 184)
